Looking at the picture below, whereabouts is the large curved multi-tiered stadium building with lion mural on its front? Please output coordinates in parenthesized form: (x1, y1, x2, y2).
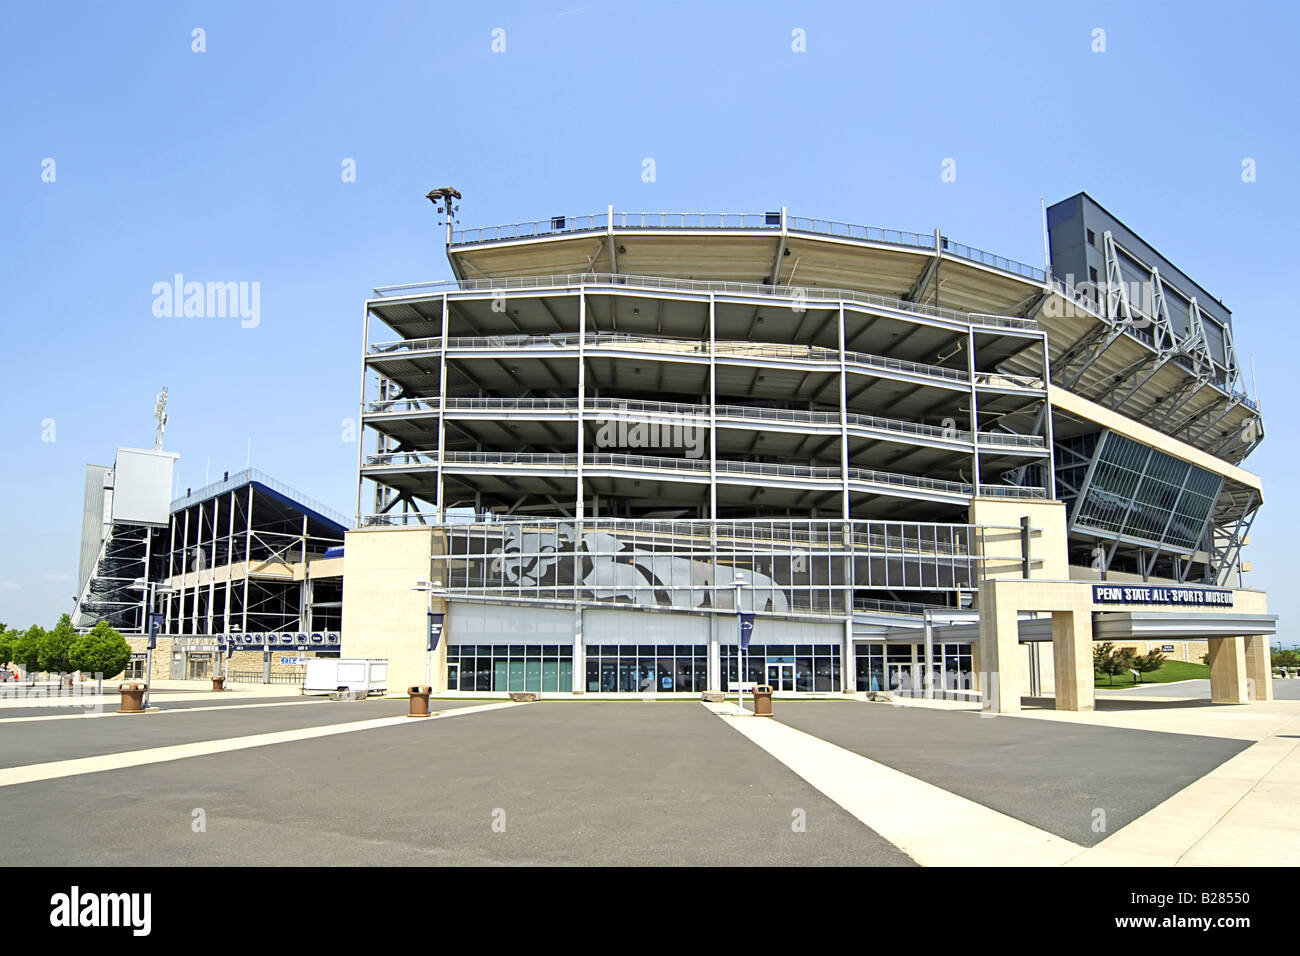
(343, 194, 1271, 710)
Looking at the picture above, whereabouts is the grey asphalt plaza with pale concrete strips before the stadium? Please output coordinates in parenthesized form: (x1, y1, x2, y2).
(0, 682, 1300, 866)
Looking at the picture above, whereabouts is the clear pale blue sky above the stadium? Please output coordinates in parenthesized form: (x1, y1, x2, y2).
(0, 0, 1300, 644)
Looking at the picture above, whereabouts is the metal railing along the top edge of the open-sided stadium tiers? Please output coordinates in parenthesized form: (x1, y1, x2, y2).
(373, 272, 1037, 330)
